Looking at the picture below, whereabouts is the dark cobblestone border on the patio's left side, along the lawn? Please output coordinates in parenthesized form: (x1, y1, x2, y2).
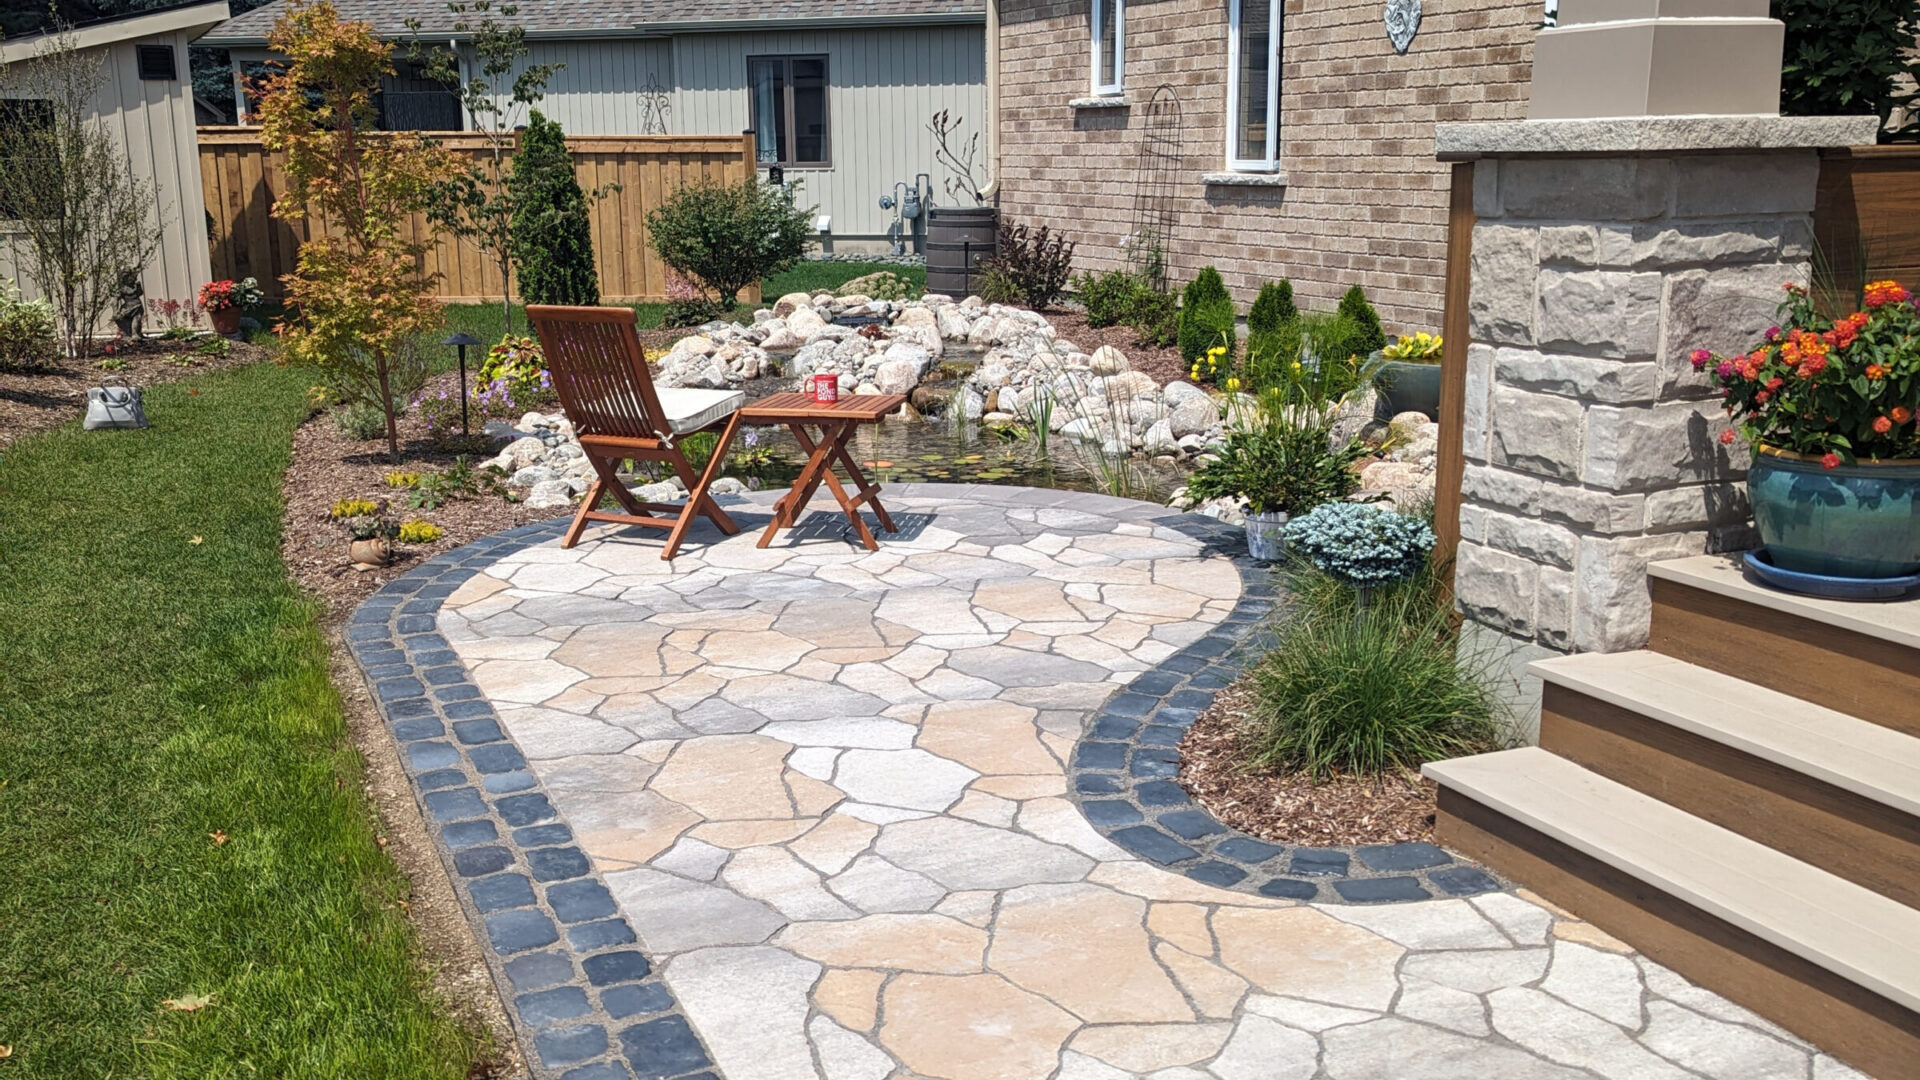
(348, 519, 720, 1080)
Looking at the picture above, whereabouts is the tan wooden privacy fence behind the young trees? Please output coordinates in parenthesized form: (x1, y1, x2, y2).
(200, 127, 755, 304)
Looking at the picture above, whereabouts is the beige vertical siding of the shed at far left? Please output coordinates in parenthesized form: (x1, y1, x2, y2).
(0, 33, 209, 317)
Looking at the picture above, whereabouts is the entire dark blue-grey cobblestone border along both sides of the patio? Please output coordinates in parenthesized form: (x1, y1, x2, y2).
(348, 484, 1501, 1080)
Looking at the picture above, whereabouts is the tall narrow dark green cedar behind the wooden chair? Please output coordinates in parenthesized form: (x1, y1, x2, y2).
(509, 110, 599, 306)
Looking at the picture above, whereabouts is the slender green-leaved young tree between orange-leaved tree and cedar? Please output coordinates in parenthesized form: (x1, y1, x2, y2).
(407, 0, 563, 332)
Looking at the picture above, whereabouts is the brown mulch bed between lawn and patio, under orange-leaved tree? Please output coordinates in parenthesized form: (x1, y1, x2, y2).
(282, 373, 568, 619)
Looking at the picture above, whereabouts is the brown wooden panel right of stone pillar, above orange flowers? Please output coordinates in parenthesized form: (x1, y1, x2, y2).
(1812, 146, 1920, 300)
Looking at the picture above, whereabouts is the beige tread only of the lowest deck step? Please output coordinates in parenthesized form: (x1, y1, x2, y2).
(1425, 746, 1920, 1011)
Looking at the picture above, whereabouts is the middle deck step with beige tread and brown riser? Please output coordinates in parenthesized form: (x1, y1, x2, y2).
(1528, 651, 1920, 909)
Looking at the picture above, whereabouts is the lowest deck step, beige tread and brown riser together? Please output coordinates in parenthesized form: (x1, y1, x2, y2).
(1425, 748, 1920, 1080)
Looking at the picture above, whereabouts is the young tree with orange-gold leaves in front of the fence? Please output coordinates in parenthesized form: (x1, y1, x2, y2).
(259, 0, 459, 457)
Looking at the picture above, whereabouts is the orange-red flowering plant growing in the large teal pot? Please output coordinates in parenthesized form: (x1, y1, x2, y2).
(1692, 281, 1920, 469)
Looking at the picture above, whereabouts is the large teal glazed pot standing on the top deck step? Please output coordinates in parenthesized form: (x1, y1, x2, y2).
(1747, 446, 1920, 578)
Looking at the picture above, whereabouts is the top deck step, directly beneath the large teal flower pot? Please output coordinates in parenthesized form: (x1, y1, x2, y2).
(1647, 555, 1920, 736)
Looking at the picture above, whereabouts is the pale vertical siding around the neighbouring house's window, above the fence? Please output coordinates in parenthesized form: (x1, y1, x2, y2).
(674, 27, 987, 236)
